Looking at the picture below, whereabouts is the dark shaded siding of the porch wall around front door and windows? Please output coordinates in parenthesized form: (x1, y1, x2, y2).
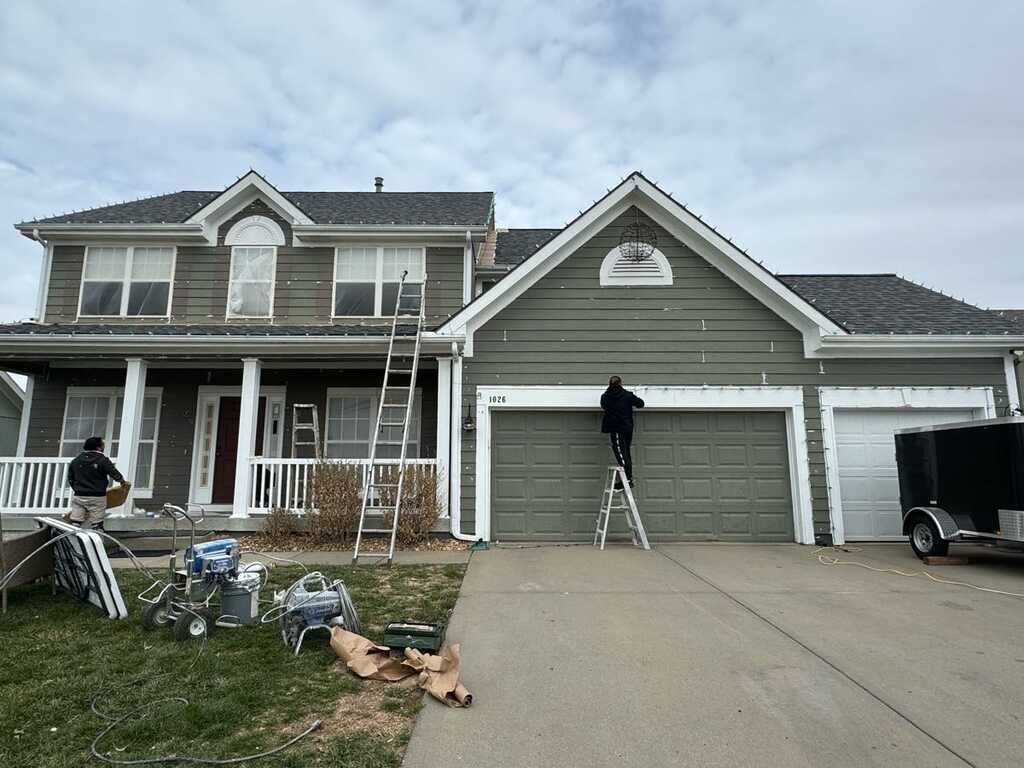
(28, 369, 437, 509)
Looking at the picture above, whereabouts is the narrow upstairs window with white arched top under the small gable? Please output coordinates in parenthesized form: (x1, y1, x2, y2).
(224, 216, 285, 317)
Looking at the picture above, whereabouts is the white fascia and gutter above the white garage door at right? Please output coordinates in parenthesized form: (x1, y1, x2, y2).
(804, 334, 1024, 358)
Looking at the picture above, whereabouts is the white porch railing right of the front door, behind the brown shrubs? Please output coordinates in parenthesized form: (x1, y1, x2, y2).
(249, 457, 437, 514)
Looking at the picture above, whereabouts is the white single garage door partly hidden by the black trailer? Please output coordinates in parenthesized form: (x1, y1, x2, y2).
(836, 409, 973, 541)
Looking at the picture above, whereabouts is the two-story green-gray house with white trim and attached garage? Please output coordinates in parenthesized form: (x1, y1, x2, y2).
(0, 172, 1024, 543)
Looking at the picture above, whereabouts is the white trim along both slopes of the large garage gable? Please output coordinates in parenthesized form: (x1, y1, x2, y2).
(438, 173, 846, 355)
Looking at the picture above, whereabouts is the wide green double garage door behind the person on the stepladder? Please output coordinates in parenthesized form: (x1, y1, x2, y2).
(490, 411, 794, 542)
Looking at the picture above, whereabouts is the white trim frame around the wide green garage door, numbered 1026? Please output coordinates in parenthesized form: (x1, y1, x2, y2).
(474, 386, 814, 544)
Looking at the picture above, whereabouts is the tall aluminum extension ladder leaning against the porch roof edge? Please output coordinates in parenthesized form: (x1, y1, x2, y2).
(352, 271, 427, 564)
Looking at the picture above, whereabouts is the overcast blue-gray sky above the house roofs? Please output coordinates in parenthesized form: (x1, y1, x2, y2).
(0, 0, 1024, 319)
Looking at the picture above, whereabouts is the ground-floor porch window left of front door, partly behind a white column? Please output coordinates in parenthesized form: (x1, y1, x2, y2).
(60, 387, 162, 493)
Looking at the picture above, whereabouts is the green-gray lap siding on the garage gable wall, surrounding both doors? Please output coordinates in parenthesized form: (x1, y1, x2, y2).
(461, 207, 1007, 534)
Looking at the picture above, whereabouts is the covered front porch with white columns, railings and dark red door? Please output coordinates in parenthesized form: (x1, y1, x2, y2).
(0, 356, 458, 530)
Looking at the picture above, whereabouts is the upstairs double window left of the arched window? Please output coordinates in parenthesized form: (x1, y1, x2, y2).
(78, 246, 174, 317)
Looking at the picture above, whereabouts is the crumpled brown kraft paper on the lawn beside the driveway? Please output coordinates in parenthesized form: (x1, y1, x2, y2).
(331, 627, 473, 707)
